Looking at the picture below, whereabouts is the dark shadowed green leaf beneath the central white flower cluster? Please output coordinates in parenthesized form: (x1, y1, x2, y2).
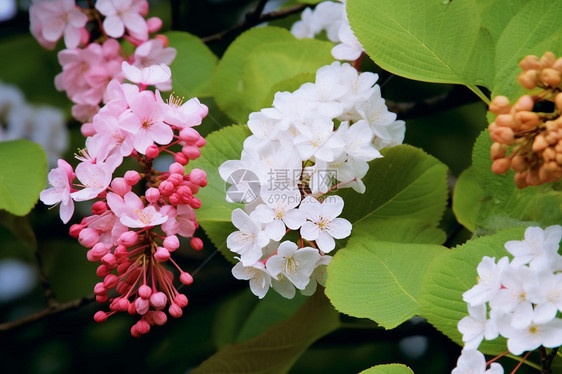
(213, 289, 307, 347)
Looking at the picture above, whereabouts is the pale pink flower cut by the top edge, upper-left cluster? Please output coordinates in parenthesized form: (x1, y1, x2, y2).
(96, 0, 148, 40)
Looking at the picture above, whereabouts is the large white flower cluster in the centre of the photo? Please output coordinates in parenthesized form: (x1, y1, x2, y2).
(219, 61, 405, 298)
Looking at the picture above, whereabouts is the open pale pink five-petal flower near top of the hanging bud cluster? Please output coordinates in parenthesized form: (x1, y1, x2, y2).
(119, 91, 174, 154)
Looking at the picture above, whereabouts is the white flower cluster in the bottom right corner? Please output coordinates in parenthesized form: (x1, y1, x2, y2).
(453, 225, 562, 374)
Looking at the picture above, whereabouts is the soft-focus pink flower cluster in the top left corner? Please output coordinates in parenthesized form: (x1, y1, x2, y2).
(29, 0, 176, 122)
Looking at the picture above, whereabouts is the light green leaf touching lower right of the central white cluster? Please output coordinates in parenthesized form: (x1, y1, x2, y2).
(326, 232, 446, 329)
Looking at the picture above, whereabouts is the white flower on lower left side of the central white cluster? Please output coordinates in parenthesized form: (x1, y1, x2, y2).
(226, 209, 269, 266)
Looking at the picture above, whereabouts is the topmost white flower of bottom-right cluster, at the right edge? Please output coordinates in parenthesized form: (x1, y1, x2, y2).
(505, 225, 562, 270)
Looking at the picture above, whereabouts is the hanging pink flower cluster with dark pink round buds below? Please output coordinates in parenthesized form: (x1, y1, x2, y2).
(40, 62, 208, 336)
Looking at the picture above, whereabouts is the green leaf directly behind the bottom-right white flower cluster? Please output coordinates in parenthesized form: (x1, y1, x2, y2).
(419, 227, 525, 354)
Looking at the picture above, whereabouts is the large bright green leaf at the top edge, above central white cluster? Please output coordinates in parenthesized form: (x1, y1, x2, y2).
(347, 0, 494, 99)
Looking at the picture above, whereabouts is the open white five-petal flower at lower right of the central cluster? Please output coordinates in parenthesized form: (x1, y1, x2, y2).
(299, 195, 351, 252)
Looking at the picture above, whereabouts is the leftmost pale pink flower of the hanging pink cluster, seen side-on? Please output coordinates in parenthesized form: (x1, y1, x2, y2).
(39, 160, 75, 223)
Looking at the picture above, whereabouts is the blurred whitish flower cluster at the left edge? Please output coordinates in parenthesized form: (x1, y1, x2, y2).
(0, 82, 69, 167)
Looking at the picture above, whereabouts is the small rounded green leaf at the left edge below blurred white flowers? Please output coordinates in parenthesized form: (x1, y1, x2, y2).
(0, 140, 47, 216)
